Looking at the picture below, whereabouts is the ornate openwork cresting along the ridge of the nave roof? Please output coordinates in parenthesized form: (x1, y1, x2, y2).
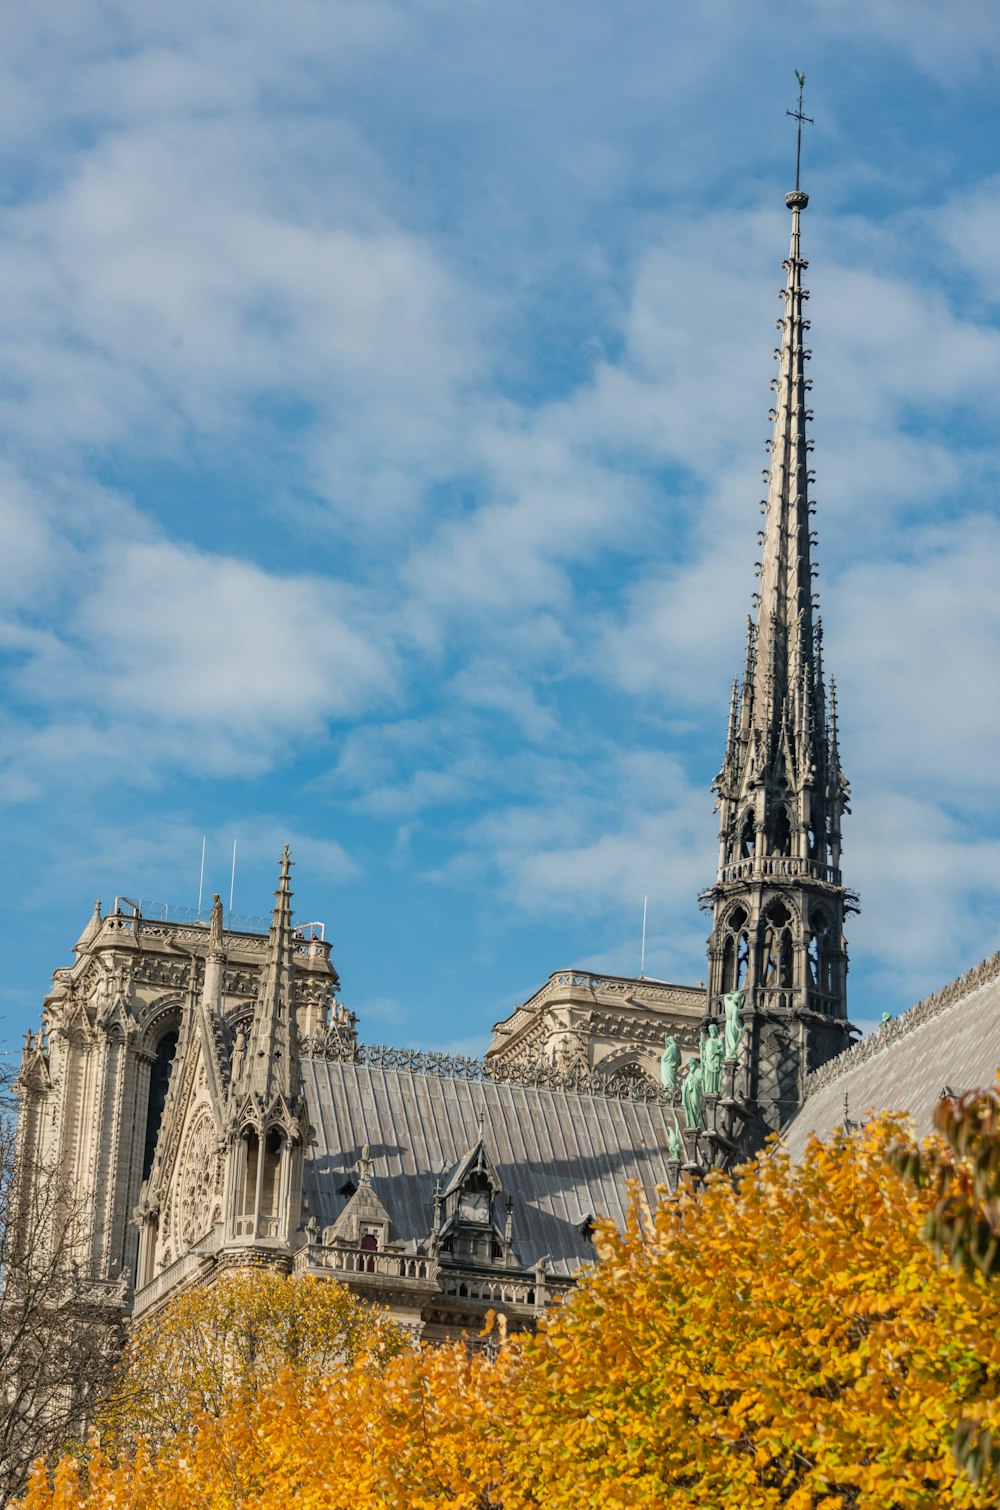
(301, 1030, 669, 1105)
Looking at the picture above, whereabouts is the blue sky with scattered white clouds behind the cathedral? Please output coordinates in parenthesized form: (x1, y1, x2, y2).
(0, 0, 1000, 1048)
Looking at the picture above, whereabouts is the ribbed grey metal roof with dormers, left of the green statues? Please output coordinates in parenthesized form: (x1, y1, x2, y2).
(302, 1059, 682, 1274)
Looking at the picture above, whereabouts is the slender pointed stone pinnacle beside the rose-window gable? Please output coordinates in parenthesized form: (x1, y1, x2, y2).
(233, 844, 302, 1126)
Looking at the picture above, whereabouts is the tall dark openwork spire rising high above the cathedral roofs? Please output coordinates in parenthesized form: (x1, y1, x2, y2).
(702, 175, 856, 1142)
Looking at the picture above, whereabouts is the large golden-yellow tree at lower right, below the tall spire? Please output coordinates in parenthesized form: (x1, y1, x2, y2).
(505, 1120, 1000, 1510)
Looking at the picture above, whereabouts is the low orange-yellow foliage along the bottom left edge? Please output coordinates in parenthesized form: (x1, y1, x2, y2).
(23, 1344, 517, 1510)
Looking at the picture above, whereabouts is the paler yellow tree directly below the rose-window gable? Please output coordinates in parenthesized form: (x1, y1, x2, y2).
(97, 1268, 405, 1454)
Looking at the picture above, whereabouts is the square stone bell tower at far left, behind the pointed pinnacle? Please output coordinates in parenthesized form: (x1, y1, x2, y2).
(12, 881, 338, 1285)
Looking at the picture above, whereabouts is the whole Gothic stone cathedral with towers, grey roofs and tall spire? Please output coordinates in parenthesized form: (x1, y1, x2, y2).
(18, 168, 1000, 1339)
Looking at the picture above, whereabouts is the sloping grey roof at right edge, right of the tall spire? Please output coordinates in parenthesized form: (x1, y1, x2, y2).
(782, 956, 1000, 1160)
